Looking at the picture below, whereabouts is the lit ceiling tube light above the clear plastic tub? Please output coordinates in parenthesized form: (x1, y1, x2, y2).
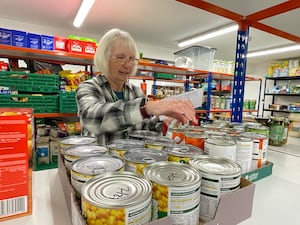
(178, 25, 239, 47)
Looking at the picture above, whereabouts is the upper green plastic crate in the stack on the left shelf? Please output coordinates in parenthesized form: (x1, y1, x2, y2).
(0, 71, 60, 93)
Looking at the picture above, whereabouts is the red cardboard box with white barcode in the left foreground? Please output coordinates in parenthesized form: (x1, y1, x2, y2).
(0, 108, 34, 221)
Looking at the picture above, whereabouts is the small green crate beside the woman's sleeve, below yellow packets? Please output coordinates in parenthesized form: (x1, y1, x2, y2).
(59, 91, 77, 113)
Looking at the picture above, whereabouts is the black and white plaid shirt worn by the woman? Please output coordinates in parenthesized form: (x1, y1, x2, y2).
(76, 76, 162, 145)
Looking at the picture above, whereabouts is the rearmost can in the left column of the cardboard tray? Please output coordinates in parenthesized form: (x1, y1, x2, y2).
(60, 136, 97, 155)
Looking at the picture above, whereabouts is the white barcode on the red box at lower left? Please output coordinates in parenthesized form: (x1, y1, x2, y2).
(0, 196, 28, 218)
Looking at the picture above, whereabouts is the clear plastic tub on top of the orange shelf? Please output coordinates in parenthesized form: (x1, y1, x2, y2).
(174, 46, 216, 71)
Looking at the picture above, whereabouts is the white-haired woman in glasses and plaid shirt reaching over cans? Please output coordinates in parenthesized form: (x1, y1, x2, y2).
(76, 29, 197, 145)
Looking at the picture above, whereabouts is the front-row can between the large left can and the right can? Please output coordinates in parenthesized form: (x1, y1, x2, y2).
(144, 162, 201, 225)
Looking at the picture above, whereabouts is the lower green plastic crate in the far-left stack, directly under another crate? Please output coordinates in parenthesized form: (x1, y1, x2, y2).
(0, 94, 58, 113)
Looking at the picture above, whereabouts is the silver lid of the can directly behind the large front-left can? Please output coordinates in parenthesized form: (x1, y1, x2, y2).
(71, 155, 125, 176)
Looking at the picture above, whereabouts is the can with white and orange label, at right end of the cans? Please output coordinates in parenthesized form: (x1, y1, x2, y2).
(242, 132, 268, 170)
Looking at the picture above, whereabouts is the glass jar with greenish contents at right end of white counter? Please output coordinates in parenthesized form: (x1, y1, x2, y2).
(269, 117, 285, 146)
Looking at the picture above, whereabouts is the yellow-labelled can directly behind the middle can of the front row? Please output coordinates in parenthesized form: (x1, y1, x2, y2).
(163, 144, 203, 163)
